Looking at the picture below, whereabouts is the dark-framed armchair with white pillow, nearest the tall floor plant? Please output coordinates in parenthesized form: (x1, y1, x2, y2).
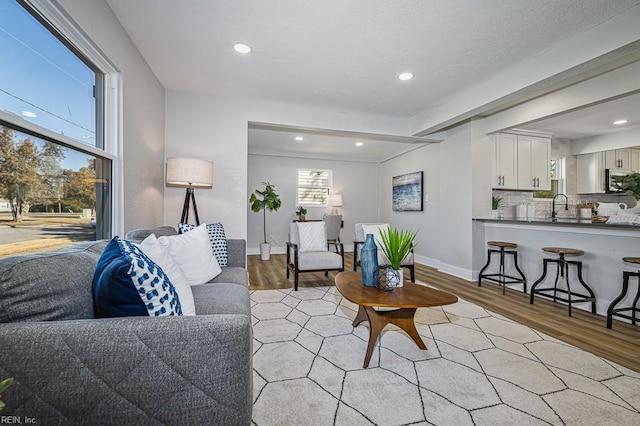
(287, 222, 344, 291)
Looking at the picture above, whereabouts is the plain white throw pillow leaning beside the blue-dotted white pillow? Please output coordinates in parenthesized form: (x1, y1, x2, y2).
(158, 225, 222, 285)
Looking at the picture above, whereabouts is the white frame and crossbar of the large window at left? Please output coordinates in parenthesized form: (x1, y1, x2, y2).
(0, 0, 124, 235)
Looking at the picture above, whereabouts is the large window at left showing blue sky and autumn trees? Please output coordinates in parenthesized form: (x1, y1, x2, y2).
(0, 0, 115, 256)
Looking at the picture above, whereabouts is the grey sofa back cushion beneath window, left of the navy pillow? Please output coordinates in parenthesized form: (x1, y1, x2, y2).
(0, 241, 107, 323)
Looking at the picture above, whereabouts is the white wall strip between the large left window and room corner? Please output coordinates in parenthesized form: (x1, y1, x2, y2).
(59, 0, 165, 233)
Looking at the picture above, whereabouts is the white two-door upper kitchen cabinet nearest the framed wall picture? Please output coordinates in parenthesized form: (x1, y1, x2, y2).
(493, 133, 551, 191)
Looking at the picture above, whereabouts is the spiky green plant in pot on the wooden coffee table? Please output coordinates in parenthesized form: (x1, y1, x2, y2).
(380, 226, 417, 288)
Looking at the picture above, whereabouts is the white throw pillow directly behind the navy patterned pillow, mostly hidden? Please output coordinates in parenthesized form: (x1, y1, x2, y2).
(138, 234, 196, 315)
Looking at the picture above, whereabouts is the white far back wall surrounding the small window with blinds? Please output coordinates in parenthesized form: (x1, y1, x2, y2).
(247, 155, 378, 254)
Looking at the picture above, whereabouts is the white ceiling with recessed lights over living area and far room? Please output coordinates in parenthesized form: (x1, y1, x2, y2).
(107, 0, 640, 161)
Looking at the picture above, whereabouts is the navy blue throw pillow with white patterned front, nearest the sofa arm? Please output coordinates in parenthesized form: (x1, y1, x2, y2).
(93, 236, 182, 318)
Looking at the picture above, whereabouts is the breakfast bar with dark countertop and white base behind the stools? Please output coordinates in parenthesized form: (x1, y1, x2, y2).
(473, 218, 640, 315)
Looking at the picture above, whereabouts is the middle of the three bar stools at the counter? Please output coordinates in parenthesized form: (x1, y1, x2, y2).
(529, 247, 596, 316)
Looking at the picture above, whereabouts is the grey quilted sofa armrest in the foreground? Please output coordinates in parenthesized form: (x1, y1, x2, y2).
(0, 315, 253, 425)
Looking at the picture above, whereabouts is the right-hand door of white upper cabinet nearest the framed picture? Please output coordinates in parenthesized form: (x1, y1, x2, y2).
(517, 135, 551, 191)
